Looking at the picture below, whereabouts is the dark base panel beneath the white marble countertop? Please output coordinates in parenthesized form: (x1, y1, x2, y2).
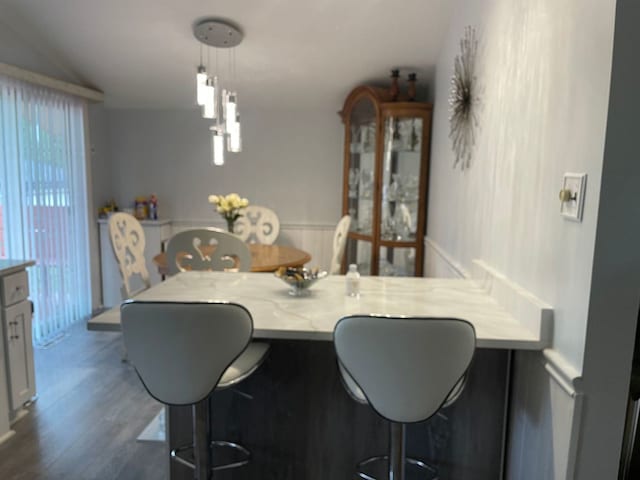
(169, 340, 509, 480)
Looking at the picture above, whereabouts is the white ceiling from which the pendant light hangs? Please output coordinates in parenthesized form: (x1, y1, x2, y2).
(0, 0, 452, 110)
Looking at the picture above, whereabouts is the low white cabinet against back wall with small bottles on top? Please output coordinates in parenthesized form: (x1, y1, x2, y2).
(98, 219, 171, 308)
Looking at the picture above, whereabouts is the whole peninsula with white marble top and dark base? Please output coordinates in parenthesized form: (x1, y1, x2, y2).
(88, 272, 551, 480)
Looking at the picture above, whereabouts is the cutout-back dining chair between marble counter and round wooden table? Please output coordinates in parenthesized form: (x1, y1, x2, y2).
(166, 228, 251, 275)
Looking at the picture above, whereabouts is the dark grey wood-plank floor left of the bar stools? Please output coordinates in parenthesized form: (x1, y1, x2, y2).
(0, 324, 167, 480)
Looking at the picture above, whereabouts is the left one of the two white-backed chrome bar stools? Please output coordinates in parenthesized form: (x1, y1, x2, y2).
(121, 300, 269, 480)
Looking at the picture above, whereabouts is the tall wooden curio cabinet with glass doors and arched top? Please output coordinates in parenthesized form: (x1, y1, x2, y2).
(341, 76, 432, 276)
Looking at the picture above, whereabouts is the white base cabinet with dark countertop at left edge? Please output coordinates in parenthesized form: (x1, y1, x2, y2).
(0, 260, 36, 441)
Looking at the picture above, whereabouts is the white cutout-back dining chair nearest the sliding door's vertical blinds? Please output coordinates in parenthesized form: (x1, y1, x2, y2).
(109, 212, 151, 300)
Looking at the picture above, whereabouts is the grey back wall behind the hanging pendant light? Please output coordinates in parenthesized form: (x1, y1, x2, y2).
(108, 106, 343, 225)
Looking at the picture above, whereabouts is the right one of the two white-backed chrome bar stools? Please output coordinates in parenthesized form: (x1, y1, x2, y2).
(333, 315, 476, 480)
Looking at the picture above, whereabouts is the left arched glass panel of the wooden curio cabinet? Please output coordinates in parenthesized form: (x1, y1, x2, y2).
(347, 98, 377, 237)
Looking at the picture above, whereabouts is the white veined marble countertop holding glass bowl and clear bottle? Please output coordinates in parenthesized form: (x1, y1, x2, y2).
(88, 272, 548, 350)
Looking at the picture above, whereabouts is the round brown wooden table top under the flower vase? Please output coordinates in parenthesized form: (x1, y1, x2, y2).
(153, 243, 311, 275)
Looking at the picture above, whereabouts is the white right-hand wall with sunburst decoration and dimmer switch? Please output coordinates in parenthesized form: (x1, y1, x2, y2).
(425, 0, 615, 480)
